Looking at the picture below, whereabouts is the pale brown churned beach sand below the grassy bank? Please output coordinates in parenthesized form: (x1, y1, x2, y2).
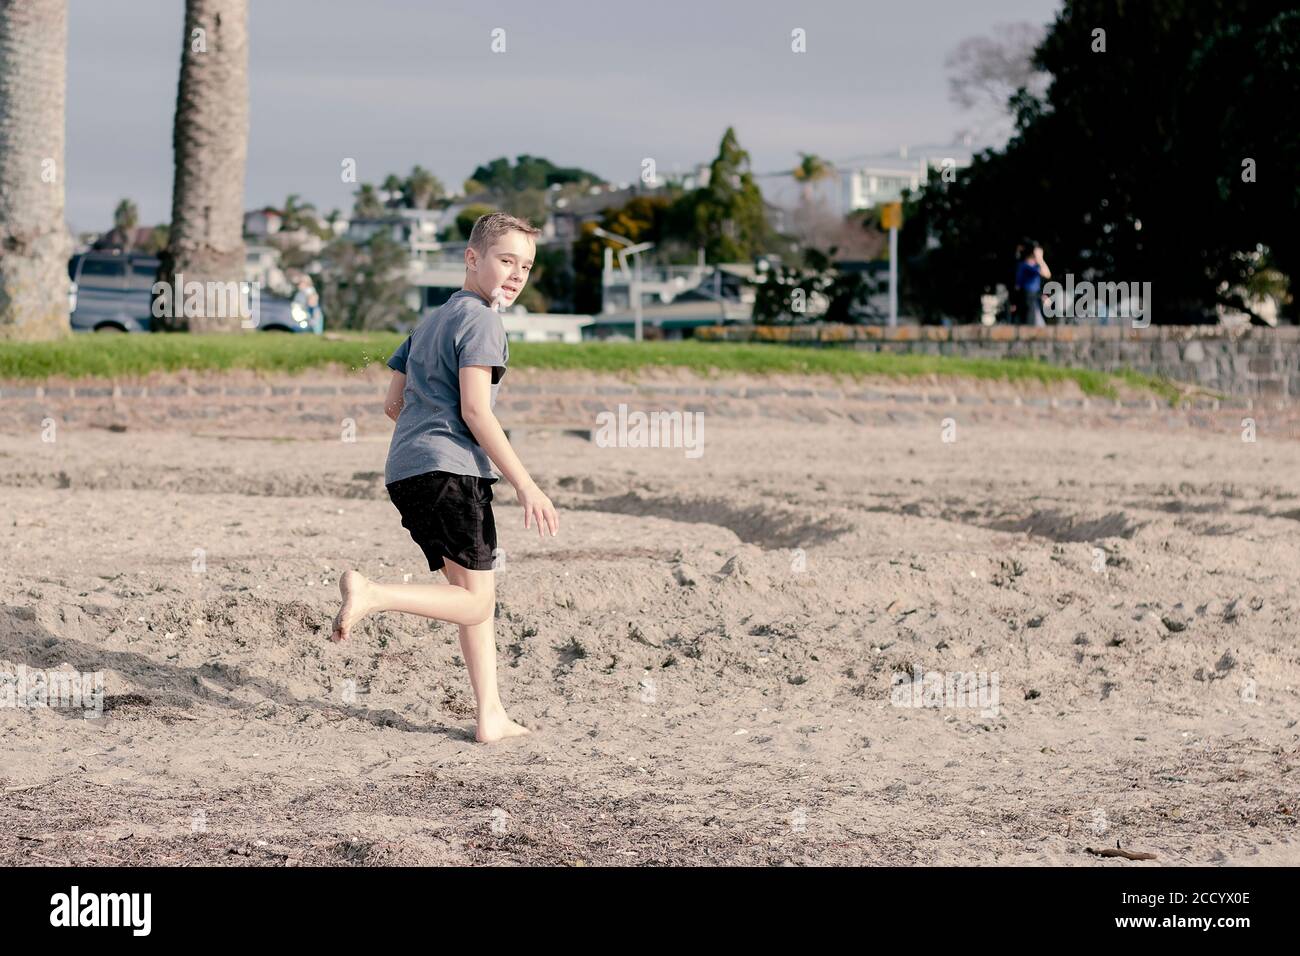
(0, 376, 1300, 866)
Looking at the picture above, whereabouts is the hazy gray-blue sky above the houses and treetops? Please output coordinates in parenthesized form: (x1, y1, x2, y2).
(66, 0, 1060, 232)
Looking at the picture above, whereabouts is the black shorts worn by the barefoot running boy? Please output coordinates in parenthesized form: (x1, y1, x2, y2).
(386, 471, 497, 571)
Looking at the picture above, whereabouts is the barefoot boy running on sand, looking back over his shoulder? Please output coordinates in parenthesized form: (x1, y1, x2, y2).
(332, 212, 559, 743)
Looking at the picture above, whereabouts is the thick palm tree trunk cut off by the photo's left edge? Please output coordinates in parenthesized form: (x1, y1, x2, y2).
(0, 0, 72, 341)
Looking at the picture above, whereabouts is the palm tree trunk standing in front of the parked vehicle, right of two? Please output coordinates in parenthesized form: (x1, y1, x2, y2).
(160, 0, 248, 332)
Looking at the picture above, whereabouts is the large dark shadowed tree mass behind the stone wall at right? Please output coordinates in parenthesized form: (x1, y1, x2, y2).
(904, 0, 1300, 323)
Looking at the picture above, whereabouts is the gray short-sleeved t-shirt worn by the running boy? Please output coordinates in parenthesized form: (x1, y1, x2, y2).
(384, 289, 510, 485)
